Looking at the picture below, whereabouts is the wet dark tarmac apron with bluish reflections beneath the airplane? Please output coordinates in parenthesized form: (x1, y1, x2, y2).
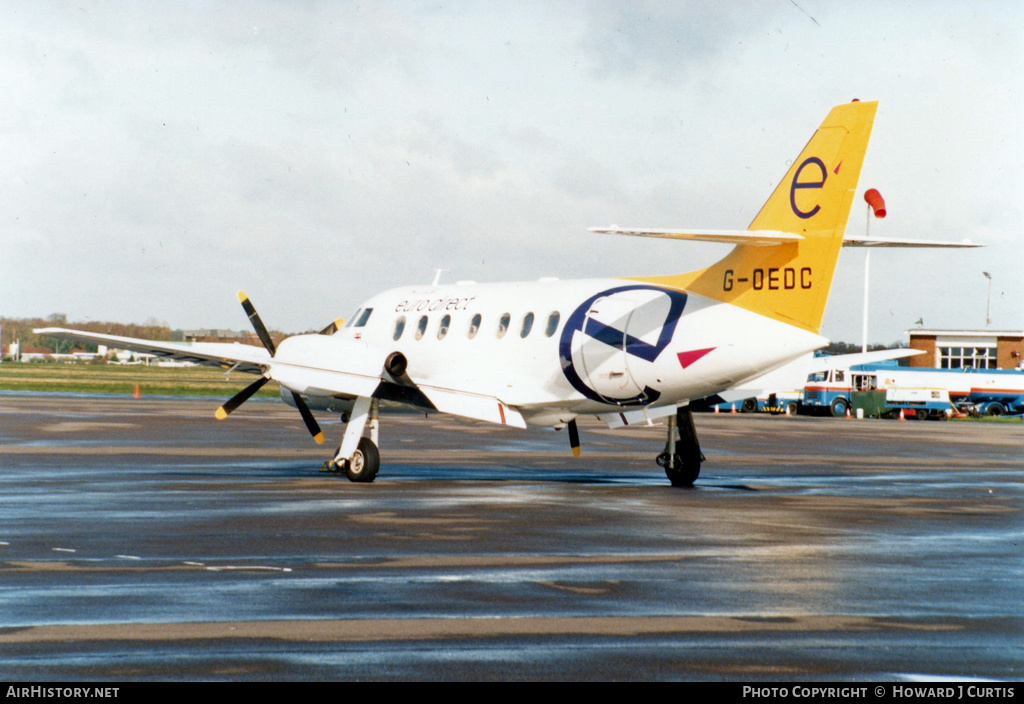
(0, 394, 1024, 680)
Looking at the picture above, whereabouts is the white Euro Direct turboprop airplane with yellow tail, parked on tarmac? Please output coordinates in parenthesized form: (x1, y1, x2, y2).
(37, 100, 897, 486)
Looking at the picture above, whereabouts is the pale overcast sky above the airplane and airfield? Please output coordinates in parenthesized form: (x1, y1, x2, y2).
(0, 0, 1024, 343)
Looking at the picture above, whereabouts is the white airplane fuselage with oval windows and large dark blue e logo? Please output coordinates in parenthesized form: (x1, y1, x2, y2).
(299, 278, 825, 426)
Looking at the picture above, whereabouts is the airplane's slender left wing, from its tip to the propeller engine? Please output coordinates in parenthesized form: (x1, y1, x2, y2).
(33, 327, 270, 373)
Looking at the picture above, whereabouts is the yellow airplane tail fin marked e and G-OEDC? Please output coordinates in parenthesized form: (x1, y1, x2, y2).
(639, 101, 878, 333)
